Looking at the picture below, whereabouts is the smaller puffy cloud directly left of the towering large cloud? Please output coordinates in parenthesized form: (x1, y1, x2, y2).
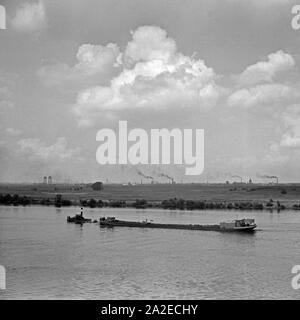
(38, 43, 120, 85)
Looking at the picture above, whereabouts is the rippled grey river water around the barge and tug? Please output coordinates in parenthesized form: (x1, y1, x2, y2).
(0, 207, 300, 299)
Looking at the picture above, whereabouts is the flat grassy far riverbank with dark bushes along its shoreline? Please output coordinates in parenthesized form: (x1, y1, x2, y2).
(0, 184, 300, 210)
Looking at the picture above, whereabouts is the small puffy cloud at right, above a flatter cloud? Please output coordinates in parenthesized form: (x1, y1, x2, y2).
(237, 50, 295, 85)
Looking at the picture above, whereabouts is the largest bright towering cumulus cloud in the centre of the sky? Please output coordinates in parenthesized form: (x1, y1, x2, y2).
(74, 26, 221, 125)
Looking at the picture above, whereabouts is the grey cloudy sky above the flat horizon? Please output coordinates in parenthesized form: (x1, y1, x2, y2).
(0, 0, 300, 183)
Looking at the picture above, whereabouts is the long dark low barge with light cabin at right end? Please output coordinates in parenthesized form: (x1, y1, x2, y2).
(99, 217, 256, 232)
